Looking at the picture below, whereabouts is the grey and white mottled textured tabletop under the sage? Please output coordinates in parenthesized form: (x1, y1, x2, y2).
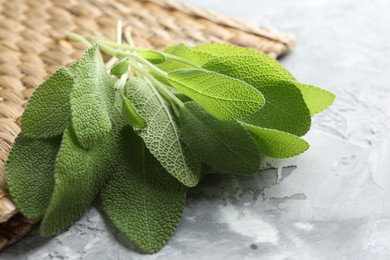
(0, 0, 390, 260)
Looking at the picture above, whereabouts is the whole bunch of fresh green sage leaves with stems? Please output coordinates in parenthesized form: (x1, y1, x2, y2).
(5, 26, 334, 253)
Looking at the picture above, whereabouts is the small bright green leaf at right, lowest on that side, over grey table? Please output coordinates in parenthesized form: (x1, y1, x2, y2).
(242, 123, 309, 158)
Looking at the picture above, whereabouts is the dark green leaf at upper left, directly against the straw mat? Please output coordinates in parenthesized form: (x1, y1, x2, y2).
(21, 68, 73, 138)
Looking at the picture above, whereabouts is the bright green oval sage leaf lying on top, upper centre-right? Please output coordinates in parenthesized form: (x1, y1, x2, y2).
(168, 69, 264, 120)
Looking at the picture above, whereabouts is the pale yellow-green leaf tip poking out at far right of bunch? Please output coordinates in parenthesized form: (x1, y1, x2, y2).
(297, 83, 336, 116)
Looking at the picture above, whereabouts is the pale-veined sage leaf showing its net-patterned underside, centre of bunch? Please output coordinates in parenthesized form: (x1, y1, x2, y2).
(126, 78, 201, 187)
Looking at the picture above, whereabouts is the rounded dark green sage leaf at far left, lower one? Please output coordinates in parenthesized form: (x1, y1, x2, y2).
(5, 134, 61, 219)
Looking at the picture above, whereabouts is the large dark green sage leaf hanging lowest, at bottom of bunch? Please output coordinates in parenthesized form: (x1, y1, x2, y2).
(101, 128, 186, 253)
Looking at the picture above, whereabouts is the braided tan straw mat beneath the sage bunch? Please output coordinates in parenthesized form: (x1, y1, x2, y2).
(0, 0, 294, 250)
